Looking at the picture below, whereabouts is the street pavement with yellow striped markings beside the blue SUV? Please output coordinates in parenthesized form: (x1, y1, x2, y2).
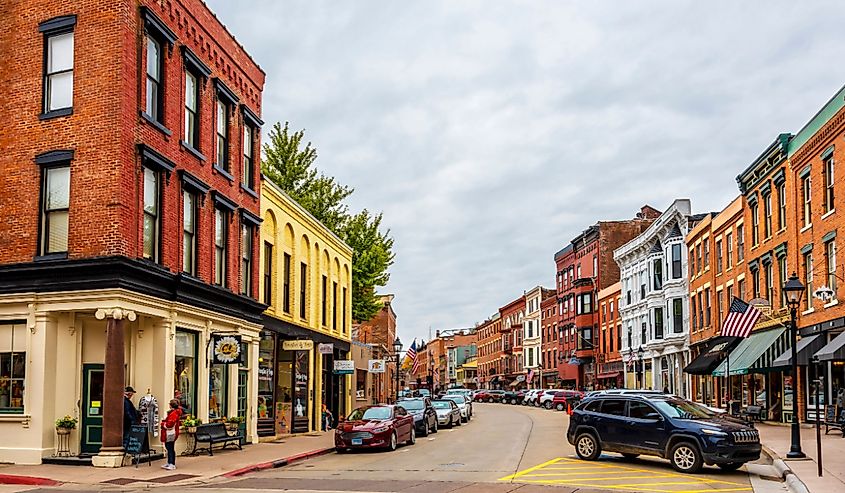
(165, 403, 783, 493)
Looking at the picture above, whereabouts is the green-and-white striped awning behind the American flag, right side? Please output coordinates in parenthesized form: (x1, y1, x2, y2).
(713, 327, 790, 377)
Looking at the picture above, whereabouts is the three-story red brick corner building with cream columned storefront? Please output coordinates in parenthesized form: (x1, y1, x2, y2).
(0, 0, 265, 465)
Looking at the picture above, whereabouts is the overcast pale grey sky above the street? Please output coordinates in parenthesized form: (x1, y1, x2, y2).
(206, 0, 845, 347)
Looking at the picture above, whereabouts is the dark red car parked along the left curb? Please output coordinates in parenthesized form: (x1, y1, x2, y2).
(334, 405, 417, 453)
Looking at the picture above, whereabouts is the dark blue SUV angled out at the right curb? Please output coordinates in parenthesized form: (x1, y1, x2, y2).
(566, 394, 760, 473)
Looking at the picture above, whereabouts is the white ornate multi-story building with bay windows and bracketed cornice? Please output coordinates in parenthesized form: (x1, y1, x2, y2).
(613, 199, 697, 395)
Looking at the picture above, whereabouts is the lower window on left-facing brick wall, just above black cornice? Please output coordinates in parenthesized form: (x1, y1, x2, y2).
(41, 165, 70, 255)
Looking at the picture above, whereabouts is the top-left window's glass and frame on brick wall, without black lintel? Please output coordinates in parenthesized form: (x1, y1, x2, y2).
(43, 31, 73, 114)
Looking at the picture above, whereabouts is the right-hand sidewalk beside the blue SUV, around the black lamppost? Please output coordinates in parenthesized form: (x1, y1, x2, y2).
(757, 424, 845, 493)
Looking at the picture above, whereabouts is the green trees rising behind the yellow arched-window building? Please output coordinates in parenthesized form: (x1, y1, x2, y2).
(262, 122, 394, 321)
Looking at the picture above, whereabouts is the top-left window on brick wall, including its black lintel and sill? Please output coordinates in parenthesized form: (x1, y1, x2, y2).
(39, 15, 76, 118)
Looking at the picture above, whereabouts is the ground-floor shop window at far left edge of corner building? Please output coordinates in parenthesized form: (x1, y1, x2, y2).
(0, 323, 26, 415)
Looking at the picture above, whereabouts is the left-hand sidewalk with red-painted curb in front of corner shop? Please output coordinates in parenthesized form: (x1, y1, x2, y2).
(0, 432, 334, 491)
